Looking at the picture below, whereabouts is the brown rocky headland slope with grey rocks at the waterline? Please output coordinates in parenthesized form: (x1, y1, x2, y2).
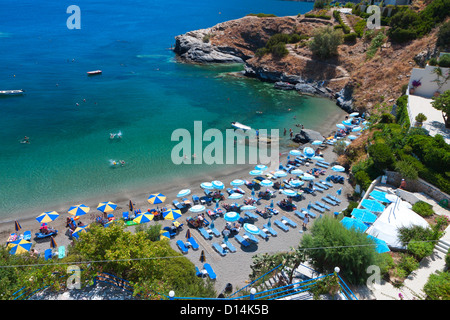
(174, 16, 436, 112)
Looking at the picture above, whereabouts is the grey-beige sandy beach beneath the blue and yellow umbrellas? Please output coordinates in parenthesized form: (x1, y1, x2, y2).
(0, 109, 352, 293)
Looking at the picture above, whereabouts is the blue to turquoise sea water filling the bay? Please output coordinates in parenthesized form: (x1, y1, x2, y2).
(0, 0, 343, 221)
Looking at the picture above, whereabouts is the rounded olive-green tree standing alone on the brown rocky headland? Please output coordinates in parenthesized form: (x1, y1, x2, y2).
(309, 26, 343, 59)
